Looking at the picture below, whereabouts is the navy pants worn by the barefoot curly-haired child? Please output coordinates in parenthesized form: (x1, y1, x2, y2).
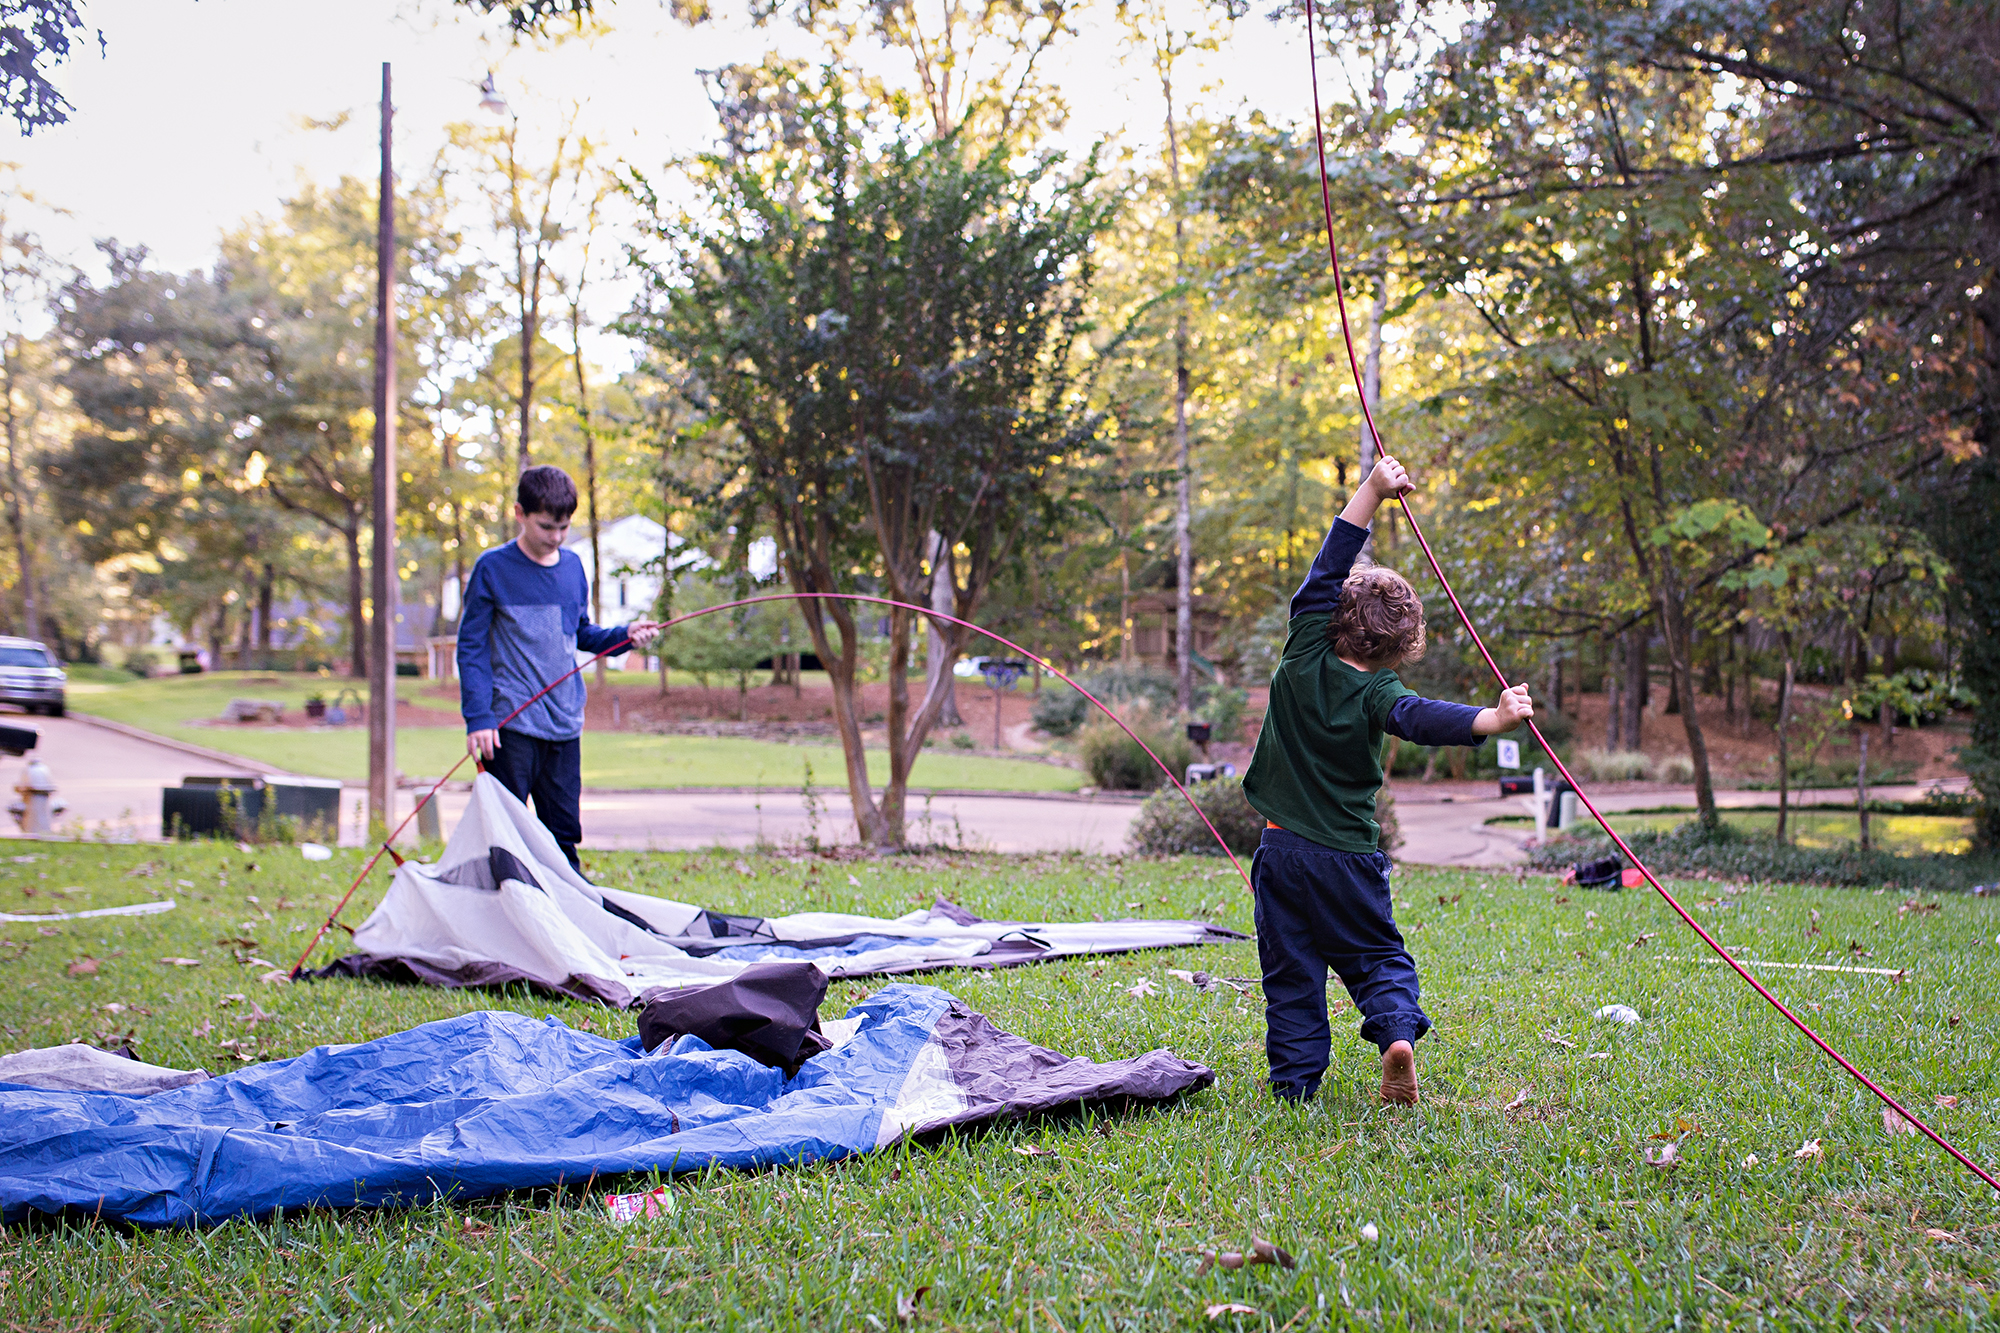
(1250, 829, 1430, 1097)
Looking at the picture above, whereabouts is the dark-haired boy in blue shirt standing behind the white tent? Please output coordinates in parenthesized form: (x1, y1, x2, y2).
(458, 466, 660, 867)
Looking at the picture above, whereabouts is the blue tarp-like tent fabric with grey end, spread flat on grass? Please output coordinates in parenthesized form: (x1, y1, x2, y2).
(0, 985, 1214, 1227)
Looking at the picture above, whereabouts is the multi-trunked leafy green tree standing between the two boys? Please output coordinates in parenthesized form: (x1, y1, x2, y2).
(626, 64, 1112, 849)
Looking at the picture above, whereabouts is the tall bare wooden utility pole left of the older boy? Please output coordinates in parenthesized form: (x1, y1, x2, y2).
(370, 60, 398, 825)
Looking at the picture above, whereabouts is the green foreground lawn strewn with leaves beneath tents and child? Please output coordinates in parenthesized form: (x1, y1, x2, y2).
(0, 845, 2000, 1333)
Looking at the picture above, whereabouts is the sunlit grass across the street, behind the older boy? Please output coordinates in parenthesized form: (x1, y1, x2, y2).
(70, 671, 1088, 791)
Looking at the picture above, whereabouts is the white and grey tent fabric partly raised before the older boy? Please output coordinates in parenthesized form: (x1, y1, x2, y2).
(320, 773, 1244, 1007)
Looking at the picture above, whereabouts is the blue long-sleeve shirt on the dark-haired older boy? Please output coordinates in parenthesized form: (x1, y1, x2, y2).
(458, 542, 626, 741)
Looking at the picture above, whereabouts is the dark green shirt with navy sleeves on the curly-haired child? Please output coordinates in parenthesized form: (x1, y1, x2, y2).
(1244, 518, 1480, 853)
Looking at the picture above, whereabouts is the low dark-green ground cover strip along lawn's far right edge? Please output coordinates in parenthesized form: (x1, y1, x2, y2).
(1528, 819, 2000, 893)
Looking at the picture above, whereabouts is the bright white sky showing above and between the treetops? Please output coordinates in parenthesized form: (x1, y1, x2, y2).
(0, 0, 1332, 290)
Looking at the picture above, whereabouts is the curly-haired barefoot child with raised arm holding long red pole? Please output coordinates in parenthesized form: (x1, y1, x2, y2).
(1244, 458, 1534, 1105)
